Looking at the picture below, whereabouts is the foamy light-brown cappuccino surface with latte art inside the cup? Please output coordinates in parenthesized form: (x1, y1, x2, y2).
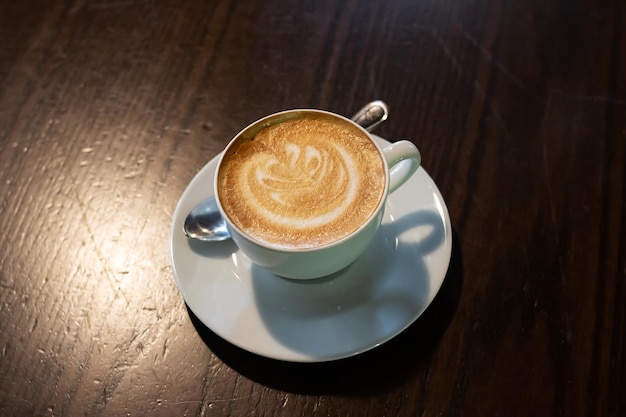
(217, 114, 387, 250)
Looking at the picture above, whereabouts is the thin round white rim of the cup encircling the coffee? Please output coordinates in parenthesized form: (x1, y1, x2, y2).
(213, 108, 390, 253)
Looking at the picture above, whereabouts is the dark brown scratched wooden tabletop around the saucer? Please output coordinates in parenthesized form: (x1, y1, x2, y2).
(0, 0, 626, 416)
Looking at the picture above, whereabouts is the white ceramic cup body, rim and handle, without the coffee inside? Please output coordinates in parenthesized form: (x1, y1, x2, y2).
(214, 109, 421, 279)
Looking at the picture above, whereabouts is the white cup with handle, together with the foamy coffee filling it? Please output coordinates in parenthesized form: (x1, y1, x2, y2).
(214, 109, 421, 279)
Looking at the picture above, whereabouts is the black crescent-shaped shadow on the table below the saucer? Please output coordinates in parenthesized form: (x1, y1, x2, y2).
(187, 232, 463, 395)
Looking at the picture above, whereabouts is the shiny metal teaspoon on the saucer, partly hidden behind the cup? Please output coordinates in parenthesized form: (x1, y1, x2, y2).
(183, 100, 389, 242)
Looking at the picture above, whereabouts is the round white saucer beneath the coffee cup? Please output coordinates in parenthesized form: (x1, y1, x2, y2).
(169, 137, 452, 362)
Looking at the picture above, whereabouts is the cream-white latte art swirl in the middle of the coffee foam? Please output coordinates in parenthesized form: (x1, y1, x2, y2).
(241, 142, 359, 229)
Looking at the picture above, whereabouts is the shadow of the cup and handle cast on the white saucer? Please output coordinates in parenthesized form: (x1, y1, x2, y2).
(252, 211, 445, 358)
